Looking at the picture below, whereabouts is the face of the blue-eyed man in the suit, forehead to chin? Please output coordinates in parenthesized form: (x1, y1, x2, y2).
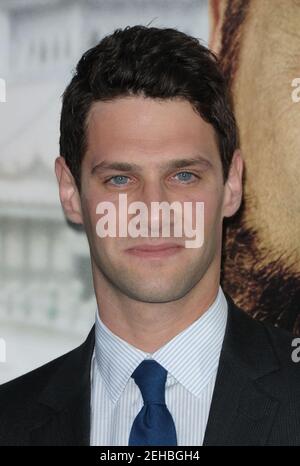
(67, 97, 237, 302)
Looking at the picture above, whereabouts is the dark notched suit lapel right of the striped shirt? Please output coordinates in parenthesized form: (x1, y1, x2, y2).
(203, 295, 279, 445)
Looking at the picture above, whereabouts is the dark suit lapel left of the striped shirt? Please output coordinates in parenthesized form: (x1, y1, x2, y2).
(29, 327, 94, 445)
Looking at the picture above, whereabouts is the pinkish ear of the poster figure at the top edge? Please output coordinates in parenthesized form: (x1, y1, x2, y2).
(208, 0, 228, 54)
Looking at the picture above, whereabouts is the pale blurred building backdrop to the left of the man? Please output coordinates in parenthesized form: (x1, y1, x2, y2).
(0, 0, 208, 383)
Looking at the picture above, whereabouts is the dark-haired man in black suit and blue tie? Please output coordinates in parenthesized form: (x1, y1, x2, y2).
(0, 26, 300, 446)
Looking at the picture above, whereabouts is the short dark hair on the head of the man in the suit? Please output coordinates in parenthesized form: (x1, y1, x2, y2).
(59, 26, 238, 189)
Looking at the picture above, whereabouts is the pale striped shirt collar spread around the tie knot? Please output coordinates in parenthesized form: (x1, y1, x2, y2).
(95, 286, 228, 403)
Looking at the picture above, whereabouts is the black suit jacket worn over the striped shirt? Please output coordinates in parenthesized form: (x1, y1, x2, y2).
(0, 295, 300, 445)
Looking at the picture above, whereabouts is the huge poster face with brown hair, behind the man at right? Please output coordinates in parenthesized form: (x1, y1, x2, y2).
(209, 0, 300, 335)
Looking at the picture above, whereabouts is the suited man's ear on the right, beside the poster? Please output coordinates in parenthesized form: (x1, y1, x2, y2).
(222, 149, 244, 217)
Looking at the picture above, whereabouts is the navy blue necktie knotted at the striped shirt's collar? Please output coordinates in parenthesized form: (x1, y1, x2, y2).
(128, 359, 177, 445)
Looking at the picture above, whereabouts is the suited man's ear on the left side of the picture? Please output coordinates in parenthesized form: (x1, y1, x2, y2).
(55, 157, 83, 224)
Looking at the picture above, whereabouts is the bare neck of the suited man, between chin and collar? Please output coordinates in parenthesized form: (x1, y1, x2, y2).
(93, 258, 220, 353)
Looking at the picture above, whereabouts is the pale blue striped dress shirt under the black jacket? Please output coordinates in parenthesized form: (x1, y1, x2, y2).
(90, 286, 228, 446)
